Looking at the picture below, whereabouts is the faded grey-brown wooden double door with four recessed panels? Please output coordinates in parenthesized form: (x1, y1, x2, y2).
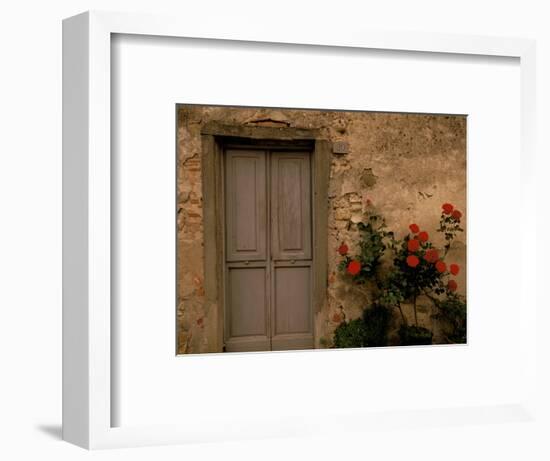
(223, 146, 313, 352)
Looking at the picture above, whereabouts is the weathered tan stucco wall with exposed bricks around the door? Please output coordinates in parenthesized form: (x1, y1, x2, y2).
(177, 106, 467, 353)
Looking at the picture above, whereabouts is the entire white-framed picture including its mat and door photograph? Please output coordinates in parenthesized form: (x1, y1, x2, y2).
(63, 12, 536, 448)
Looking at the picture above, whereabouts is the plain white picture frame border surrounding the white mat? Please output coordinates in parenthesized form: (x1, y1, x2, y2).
(63, 12, 537, 448)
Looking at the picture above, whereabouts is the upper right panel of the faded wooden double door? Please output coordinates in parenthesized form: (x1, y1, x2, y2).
(271, 152, 311, 260)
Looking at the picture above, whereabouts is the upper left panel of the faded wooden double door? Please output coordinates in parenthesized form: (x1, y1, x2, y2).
(226, 150, 267, 261)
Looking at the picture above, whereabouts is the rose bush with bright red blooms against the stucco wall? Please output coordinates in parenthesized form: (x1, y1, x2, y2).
(338, 203, 465, 344)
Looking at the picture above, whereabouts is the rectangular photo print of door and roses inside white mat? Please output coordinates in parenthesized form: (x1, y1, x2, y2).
(175, 104, 467, 354)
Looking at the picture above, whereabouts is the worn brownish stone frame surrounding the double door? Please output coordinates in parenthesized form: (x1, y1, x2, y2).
(201, 122, 331, 352)
